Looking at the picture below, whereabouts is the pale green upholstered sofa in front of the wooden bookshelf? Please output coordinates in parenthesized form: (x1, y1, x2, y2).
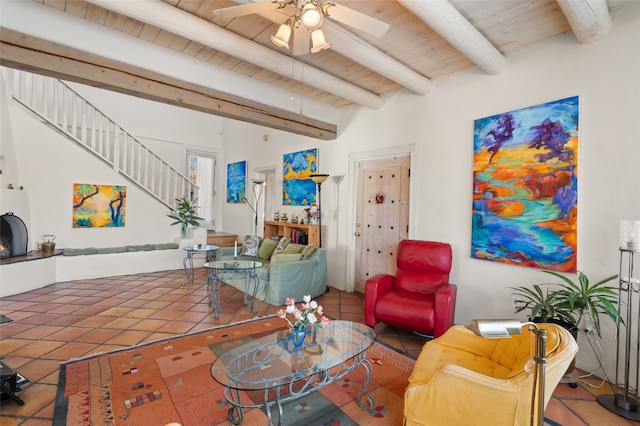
(217, 243, 327, 305)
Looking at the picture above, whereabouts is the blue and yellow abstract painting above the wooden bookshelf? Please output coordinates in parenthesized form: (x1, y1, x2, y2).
(282, 148, 318, 206)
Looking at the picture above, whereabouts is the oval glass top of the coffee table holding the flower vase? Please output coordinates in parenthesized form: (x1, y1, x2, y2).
(211, 321, 376, 390)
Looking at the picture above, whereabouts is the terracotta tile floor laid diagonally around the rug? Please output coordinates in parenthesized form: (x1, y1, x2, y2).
(0, 269, 638, 426)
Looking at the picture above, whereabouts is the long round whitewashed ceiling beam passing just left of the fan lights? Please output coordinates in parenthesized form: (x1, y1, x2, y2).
(87, 0, 382, 109)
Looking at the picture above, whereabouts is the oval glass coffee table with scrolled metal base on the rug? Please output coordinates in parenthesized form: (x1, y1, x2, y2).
(211, 321, 376, 425)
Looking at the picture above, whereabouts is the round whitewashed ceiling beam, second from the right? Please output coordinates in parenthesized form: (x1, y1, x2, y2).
(398, 0, 507, 75)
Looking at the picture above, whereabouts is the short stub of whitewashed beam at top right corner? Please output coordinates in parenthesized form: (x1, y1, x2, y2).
(557, 0, 611, 44)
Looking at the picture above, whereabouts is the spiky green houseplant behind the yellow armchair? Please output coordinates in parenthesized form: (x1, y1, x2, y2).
(511, 271, 622, 336)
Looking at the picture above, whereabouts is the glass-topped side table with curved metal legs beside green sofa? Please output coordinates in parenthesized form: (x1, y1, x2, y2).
(204, 260, 262, 319)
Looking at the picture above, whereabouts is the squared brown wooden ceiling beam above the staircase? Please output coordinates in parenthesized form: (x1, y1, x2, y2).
(0, 28, 337, 140)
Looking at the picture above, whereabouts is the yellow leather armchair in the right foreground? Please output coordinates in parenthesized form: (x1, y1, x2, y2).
(404, 324, 578, 426)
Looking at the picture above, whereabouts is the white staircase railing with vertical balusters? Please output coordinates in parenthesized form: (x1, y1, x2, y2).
(13, 70, 198, 208)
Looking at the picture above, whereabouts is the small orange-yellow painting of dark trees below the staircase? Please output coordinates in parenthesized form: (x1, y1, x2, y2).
(73, 183, 127, 228)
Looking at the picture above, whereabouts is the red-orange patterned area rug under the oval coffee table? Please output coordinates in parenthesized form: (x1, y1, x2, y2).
(54, 316, 414, 426)
